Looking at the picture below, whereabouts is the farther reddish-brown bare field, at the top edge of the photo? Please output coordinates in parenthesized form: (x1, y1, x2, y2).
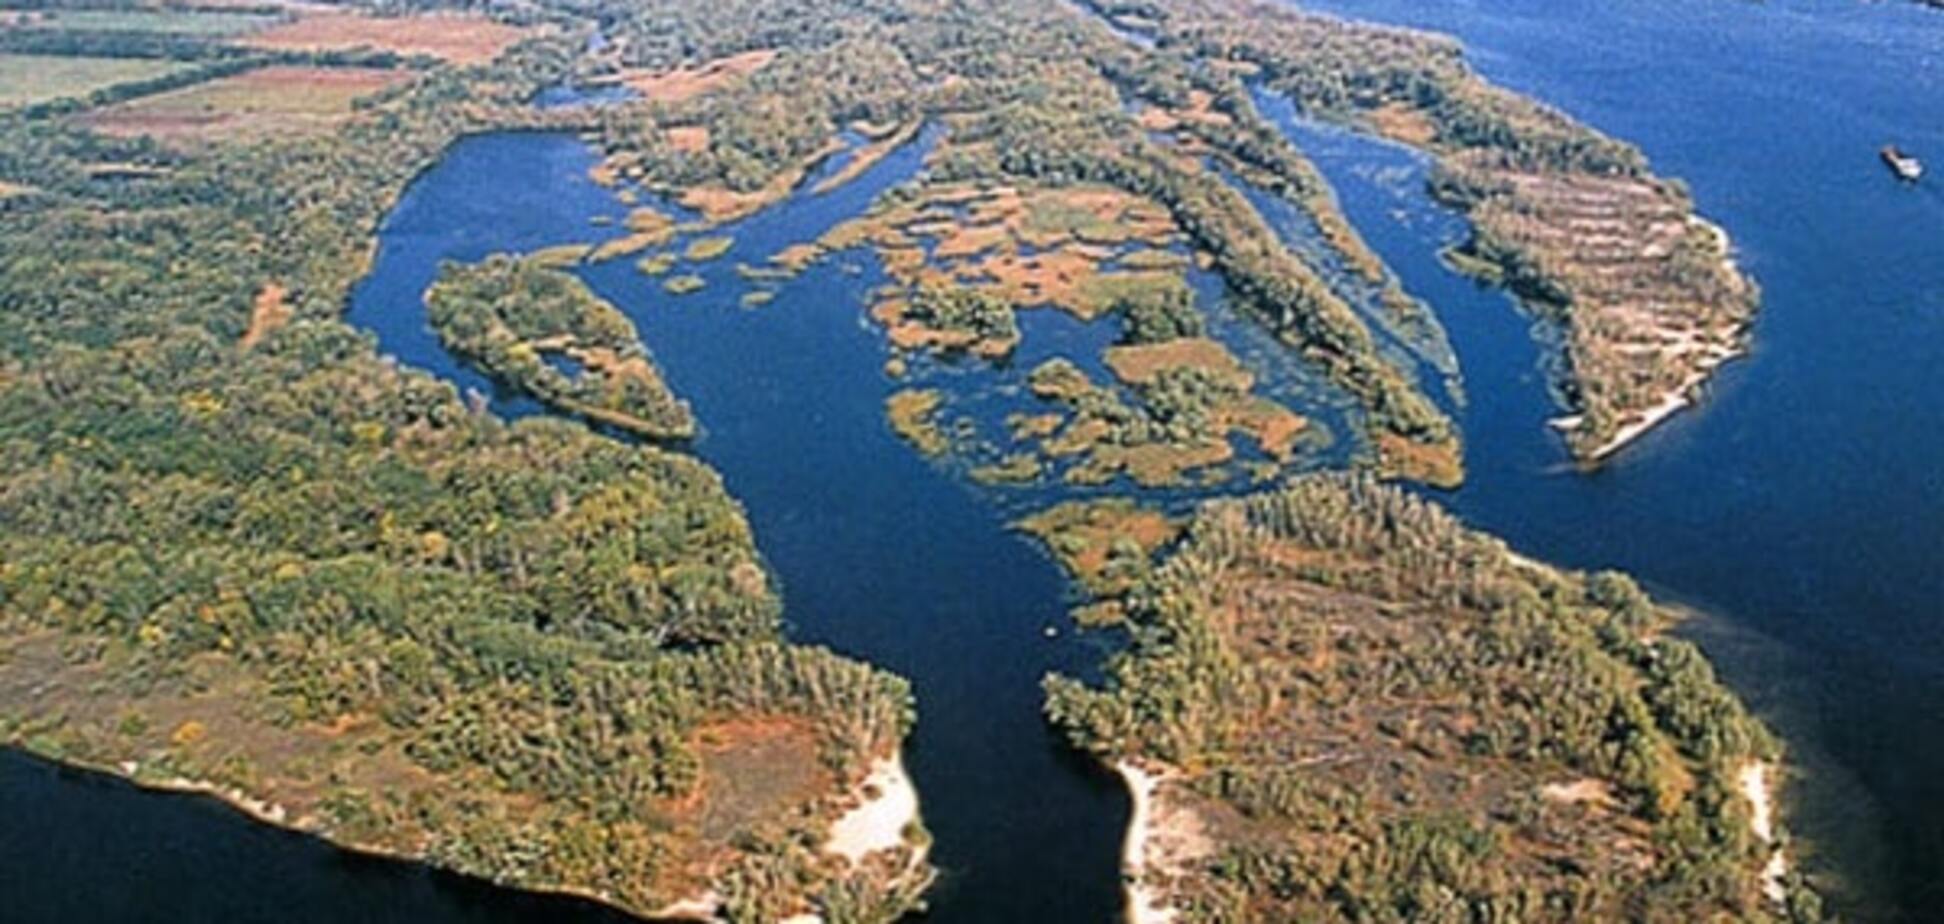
(243, 12, 527, 64)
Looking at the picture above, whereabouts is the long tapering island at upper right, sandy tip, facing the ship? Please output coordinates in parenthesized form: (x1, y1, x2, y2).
(1091, 0, 1759, 465)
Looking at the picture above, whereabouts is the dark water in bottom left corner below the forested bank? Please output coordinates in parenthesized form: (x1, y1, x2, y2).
(0, 751, 636, 924)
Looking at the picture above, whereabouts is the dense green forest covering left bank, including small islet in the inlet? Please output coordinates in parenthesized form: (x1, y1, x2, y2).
(0, 5, 927, 920)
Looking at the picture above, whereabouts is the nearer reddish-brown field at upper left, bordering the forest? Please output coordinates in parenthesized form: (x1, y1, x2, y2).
(86, 68, 408, 140)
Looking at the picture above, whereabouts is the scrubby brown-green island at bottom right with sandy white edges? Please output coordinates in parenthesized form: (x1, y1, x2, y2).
(1038, 475, 1822, 922)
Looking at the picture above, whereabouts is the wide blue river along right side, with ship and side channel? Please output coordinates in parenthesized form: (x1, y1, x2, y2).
(1267, 0, 1944, 920)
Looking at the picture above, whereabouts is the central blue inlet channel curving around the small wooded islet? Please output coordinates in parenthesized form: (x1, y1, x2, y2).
(350, 124, 1126, 920)
